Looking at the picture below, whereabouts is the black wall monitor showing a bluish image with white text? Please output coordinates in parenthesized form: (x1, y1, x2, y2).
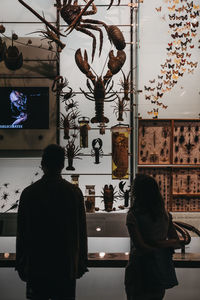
(0, 87, 49, 129)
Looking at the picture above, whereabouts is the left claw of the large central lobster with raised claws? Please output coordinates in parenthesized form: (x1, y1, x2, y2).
(75, 48, 95, 80)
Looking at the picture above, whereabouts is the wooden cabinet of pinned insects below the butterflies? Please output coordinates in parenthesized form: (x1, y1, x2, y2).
(138, 119, 200, 212)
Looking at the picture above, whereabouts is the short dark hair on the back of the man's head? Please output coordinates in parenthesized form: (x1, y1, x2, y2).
(41, 144, 65, 171)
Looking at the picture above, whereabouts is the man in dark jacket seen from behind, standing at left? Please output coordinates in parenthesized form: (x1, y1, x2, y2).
(16, 144, 87, 300)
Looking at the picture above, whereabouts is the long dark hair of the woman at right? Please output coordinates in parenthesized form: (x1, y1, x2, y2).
(132, 174, 166, 221)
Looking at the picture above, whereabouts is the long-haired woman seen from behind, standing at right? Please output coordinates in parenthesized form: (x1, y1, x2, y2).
(125, 174, 181, 300)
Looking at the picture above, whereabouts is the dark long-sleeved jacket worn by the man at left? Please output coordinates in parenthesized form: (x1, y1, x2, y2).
(16, 175, 87, 281)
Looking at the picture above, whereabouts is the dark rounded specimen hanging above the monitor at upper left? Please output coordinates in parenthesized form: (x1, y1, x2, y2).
(4, 34, 23, 71)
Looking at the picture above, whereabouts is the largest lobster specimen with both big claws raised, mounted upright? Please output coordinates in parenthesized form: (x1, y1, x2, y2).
(75, 49, 126, 123)
